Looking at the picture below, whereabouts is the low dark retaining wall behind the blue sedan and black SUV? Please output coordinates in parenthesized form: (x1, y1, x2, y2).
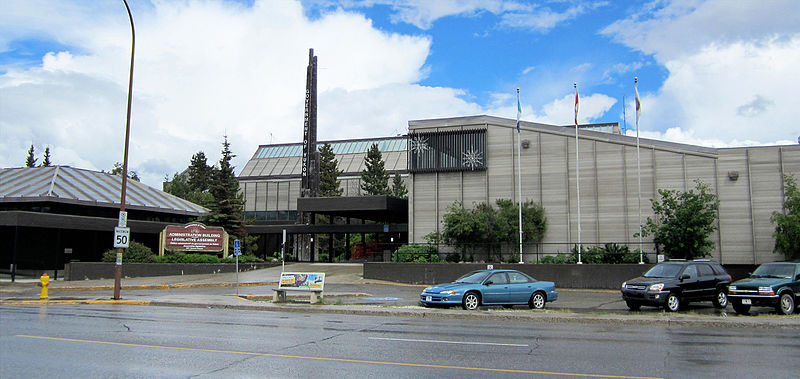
(364, 262, 755, 289)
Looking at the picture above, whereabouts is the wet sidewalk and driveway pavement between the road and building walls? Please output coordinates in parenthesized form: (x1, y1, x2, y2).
(0, 263, 800, 329)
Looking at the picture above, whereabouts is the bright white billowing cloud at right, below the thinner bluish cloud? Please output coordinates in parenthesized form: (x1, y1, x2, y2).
(640, 35, 800, 143)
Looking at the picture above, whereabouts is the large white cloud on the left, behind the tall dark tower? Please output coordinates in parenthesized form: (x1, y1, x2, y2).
(0, 1, 444, 188)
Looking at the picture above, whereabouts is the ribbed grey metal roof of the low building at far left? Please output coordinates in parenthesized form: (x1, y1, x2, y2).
(0, 166, 209, 216)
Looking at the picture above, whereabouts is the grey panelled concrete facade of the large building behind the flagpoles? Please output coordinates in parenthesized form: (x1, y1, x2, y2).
(409, 117, 800, 264)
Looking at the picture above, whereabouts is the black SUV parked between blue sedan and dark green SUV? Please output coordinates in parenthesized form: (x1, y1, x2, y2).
(622, 260, 731, 312)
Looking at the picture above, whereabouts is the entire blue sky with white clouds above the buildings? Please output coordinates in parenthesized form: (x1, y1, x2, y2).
(0, 0, 800, 188)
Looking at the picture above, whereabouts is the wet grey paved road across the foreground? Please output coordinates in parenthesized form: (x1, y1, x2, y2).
(0, 305, 800, 378)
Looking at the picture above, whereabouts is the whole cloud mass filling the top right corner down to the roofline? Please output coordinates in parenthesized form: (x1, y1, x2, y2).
(602, 0, 800, 147)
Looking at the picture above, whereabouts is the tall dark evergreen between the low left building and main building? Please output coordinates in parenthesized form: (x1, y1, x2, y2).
(206, 135, 247, 240)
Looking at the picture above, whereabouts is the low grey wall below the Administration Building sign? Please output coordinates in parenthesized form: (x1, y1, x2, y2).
(64, 262, 280, 280)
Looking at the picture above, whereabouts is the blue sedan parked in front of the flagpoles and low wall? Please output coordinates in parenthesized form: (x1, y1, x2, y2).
(420, 270, 558, 310)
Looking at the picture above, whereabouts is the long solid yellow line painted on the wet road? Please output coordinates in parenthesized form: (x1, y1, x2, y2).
(16, 334, 663, 379)
